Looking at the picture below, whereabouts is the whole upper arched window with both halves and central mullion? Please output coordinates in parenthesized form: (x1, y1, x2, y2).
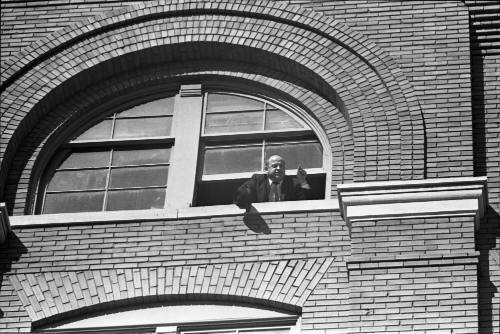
(37, 85, 325, 213)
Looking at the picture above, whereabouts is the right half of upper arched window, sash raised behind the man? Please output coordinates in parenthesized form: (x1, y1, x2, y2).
(196, 92, 325, 205)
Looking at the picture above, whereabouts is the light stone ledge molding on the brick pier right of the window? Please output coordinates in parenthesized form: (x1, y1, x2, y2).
(337, 177, 487, 227)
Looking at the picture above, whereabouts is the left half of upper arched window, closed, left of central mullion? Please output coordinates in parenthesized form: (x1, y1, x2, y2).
(38, 97, 174, 213)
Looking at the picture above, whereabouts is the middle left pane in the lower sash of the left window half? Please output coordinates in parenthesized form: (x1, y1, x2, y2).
(48, 169, 108, 191)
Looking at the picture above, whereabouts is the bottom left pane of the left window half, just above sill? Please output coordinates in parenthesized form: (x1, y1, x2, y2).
(43, 191, 104, 213)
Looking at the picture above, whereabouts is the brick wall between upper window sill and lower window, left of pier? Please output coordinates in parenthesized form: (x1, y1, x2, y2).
(0, 212, 349, 331)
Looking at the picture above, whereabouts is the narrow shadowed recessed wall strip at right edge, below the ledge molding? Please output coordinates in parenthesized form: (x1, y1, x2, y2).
(476, 206, 500, 334)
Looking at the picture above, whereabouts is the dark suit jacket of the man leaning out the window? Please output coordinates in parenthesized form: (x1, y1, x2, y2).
(233, 174, 307, 209)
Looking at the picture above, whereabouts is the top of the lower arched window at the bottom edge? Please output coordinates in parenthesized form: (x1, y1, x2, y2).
(37, 303, 298, 334)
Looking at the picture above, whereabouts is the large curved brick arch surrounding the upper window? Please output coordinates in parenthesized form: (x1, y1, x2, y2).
(0, 2, 424, 204)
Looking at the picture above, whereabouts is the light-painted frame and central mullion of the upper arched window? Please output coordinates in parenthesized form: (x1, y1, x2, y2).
(34, 84, 332, 212)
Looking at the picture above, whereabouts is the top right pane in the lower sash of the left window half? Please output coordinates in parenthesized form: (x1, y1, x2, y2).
(113, 148, 171, 166)
